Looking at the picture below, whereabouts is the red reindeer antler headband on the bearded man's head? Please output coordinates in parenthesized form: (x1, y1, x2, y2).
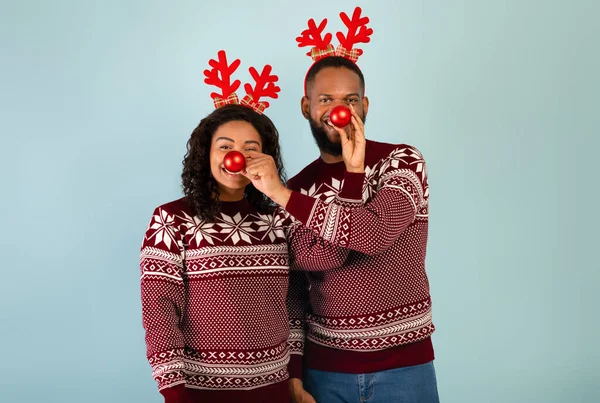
(296, 7, 373, 91)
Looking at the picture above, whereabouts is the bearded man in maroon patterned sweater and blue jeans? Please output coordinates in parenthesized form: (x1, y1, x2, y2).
(282, 8, 439, 403)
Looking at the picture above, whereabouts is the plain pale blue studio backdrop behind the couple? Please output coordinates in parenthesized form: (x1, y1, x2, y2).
(0, 0, 600, 403)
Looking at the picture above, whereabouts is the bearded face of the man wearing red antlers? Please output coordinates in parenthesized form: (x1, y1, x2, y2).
(301, 67, 369, 156)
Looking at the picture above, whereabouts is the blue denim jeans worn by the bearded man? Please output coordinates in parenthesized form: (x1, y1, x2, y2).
(303, 362, 440, 403)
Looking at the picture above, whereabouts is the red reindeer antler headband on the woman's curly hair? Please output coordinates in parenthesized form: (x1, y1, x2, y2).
(204, 50, 281, 114)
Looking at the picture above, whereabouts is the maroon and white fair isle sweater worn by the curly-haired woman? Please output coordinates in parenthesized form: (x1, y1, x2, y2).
(140, 199, 343, 402)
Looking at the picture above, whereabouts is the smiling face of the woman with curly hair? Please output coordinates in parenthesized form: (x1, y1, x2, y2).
(210, 120, 262, 201)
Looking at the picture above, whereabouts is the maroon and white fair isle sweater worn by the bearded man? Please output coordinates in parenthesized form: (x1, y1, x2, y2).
(286, 140, 434, 378)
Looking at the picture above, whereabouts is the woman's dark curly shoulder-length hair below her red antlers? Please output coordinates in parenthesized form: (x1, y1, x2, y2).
(181, 105, 286, 220)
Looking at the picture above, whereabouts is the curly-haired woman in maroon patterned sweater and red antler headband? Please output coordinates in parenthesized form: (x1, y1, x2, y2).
(140, 52, 366, 403)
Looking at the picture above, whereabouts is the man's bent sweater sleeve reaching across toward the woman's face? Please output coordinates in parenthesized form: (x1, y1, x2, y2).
(282, 146, 429, 255)
